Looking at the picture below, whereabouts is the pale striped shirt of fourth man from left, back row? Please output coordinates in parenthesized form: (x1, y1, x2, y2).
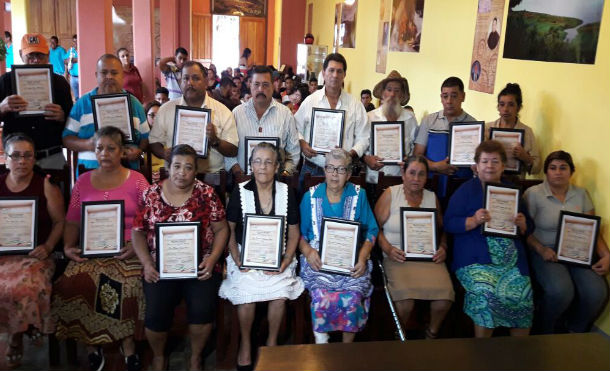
(225, 98, 301, 174)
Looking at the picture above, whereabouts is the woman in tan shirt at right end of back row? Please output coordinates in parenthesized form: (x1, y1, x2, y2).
(485, 83, 541, 179)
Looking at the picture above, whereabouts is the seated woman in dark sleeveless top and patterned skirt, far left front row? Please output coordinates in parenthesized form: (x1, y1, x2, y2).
(0, 133, 64, 368)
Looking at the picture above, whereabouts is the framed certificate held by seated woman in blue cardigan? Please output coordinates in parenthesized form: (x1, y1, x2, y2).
(482, 183, 521, 237)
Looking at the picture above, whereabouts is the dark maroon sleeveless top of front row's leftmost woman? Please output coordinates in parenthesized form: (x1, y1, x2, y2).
(0, 173, 53, 244)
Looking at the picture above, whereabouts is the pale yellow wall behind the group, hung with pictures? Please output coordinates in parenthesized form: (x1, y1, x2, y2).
(308, 0, 610, 334)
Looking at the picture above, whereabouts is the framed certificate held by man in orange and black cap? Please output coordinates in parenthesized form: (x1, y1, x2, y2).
(12, 64, 53, 116)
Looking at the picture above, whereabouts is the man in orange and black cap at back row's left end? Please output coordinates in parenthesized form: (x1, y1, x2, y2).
(0, 34, 72, 169)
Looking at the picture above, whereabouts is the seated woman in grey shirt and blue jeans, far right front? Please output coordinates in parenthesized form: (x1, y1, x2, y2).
(525, 151, 610, 334)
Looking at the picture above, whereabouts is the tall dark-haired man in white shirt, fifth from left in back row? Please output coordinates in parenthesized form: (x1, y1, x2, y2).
(294, 53, 371, 186)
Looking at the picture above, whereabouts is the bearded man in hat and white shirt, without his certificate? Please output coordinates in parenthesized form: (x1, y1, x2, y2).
(364, 71, 417, 184)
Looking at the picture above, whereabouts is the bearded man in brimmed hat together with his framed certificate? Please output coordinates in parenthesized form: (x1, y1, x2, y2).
(364, 71, 417, 184)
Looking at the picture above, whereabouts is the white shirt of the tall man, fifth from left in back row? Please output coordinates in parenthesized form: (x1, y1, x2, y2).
(294, 87, 371, 167)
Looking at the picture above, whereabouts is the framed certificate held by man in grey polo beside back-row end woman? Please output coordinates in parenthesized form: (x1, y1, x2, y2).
(449, 121, 485, 167)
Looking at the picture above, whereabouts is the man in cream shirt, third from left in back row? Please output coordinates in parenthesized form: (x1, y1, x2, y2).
(150, 61, 239, 173)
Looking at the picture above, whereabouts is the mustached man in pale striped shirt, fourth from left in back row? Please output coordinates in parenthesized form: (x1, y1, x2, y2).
(225, 66, 301, 175)
